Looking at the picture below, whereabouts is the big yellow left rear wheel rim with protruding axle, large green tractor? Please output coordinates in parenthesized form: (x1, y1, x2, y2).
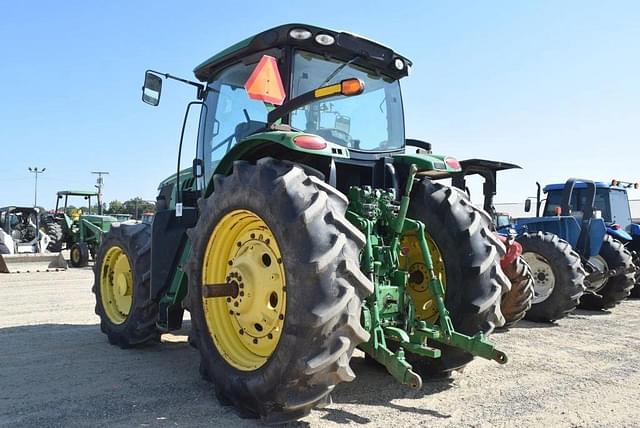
(202, 210, 287, 371)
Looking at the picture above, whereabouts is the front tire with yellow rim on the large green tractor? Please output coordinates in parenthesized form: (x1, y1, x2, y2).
(92, 223, 160, 348)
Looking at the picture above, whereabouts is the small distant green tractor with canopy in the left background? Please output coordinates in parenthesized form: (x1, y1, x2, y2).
(42, 190, 121, 267)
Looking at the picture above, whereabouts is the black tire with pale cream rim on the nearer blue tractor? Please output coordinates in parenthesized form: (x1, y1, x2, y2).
(517, 232, 586, 322)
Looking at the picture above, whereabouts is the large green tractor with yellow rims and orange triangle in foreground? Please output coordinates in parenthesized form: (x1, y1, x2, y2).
(93, 24, 509, 423)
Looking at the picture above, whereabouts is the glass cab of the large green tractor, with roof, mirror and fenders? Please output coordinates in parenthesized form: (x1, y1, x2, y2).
(142, 24, 459, 207)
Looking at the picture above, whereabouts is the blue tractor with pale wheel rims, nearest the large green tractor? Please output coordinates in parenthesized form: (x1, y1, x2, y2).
(515, 178, 635, 312)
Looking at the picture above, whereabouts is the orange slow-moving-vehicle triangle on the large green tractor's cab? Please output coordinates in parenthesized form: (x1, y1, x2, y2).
(244, 55, 287, 106)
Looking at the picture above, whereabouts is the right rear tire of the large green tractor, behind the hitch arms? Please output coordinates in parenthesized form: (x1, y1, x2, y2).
(407, 179, 510, 376)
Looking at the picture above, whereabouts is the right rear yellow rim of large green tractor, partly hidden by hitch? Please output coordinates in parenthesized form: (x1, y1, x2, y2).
(400, 234, 447, 323)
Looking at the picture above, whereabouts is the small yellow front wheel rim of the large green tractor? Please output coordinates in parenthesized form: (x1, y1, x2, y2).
(100, 245, 133, 324)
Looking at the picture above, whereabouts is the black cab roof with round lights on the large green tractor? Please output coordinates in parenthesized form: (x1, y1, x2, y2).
(193, 24, 412, 82)
